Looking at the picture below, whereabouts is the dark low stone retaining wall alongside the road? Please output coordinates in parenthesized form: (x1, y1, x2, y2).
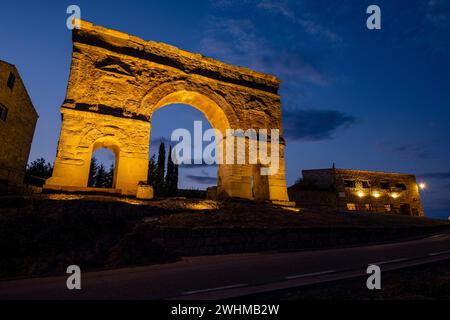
(147, 227, 444, 256)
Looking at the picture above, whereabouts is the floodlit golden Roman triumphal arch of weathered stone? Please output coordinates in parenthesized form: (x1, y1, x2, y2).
(45, 21, 288, 201)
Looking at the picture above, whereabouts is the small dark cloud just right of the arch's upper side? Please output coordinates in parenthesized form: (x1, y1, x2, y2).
(283, 109, 356, 141)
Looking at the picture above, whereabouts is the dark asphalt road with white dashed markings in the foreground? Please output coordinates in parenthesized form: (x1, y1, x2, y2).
(0, 231, 450, 300)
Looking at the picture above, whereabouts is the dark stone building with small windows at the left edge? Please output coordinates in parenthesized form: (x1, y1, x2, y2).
(0, 60, 38, 193)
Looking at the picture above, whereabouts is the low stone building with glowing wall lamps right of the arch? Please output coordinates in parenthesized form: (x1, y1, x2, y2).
(288, 168, 424, 216)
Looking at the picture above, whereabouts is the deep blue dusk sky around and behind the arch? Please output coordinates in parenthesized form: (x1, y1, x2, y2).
(0, 0, 450, 217)
